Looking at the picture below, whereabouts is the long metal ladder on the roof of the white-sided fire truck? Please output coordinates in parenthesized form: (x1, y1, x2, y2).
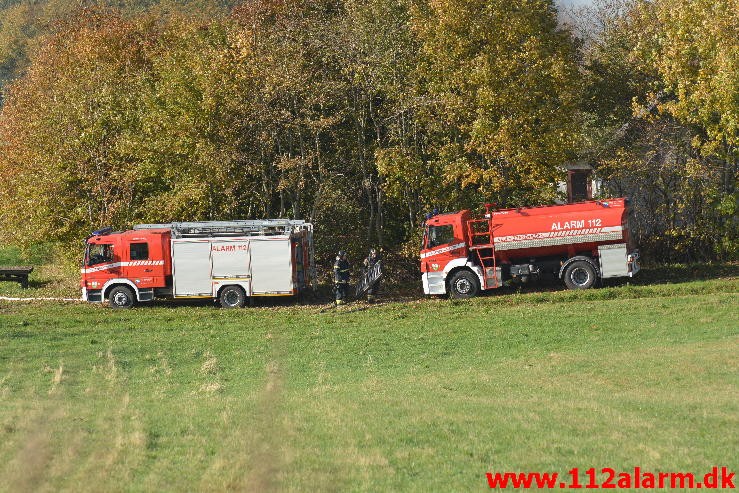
(133, 219, 313, 238)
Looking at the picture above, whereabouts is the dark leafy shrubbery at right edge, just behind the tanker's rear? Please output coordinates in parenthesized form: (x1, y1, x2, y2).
(598, 117, 739, 262)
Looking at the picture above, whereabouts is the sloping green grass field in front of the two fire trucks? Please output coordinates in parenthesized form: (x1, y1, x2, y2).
(0, 280, 739, 491)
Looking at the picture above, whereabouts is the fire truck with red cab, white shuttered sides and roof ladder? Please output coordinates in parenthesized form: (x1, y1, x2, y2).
(81, 219, 315, 308)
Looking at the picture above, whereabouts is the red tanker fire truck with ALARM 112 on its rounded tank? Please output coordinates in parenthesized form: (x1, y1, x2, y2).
(421, 198, 639, 298)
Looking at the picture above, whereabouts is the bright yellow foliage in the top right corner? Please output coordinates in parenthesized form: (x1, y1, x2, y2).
(634, 0, 739, 157)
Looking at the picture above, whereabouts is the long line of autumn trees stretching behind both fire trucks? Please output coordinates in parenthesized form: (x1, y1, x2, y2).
(0, 0, 739, 261)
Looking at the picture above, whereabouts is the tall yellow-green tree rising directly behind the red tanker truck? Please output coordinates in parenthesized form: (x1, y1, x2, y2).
(416, 0, 580, 206)
